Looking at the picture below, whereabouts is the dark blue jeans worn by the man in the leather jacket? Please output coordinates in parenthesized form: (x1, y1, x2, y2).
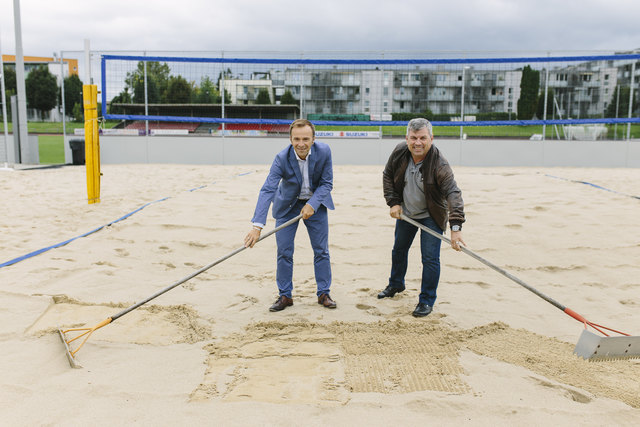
(389, 217, 442, 307)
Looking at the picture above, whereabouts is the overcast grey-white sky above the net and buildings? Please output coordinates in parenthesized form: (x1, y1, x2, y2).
(0, 0, 640, 56)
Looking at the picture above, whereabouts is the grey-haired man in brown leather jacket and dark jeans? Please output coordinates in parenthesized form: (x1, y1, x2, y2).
(378, 119, 465, 317)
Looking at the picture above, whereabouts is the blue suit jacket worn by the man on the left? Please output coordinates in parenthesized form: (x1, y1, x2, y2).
(251, 141, 334, 224)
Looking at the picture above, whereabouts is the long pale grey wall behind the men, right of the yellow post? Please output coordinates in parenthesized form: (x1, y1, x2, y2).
(100, 136, 640, 168)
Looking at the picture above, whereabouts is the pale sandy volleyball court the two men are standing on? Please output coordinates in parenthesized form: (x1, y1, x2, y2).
(0, 165, 640, 425)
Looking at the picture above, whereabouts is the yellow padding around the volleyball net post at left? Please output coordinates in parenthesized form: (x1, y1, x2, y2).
(82, 85, 100, 204)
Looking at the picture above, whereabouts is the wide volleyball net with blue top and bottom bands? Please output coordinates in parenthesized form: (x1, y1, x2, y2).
(101, 53, 640, 139)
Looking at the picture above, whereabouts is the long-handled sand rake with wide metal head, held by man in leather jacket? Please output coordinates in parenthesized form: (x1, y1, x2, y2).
(401, 214, 640, 361)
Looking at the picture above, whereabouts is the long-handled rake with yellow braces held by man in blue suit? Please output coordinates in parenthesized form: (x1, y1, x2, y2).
(58, 215, 302, 368)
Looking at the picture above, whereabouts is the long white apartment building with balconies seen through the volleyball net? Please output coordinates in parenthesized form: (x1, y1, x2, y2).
(219, 55, 640, 120)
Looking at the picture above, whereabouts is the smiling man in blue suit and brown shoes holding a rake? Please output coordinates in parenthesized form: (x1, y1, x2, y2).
(244, 119, 336, 311)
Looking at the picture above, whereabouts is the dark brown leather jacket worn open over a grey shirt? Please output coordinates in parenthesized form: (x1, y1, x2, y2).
(382, 142, 465, 231)
